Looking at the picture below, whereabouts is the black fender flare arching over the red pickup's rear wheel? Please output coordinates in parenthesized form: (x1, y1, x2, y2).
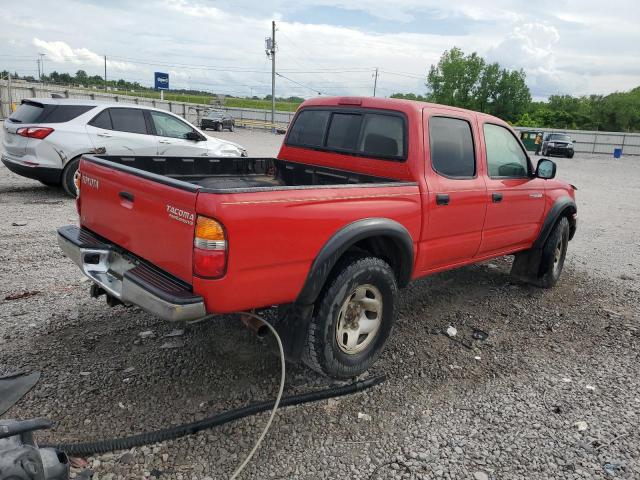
(296, 218, 414, 305)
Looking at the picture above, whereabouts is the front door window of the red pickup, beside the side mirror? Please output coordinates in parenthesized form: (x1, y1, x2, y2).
(484, 123, 529, 178)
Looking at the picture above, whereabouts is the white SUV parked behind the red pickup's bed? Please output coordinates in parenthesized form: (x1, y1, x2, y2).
(2, 98, 247, 195)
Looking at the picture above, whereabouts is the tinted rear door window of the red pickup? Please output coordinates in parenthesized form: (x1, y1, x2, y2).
(429, 117, 476, 178)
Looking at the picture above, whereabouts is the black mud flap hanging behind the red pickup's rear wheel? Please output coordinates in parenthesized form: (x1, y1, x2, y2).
(274, 303, 313, 363)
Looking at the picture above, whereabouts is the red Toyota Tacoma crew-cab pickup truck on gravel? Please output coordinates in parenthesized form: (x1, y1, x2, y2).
(58, 97, 576, 378)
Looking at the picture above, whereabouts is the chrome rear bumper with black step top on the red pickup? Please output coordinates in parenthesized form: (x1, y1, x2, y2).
(58, 226, 207, 321)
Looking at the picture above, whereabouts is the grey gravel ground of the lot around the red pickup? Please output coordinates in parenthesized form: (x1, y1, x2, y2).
(0, 130, 640, 480)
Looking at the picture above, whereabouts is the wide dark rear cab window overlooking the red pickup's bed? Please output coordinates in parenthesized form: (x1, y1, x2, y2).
(285, 108, 407, 161)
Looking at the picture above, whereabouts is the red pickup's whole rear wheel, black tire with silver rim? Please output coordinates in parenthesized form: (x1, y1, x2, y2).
(302, 257, 398, 379)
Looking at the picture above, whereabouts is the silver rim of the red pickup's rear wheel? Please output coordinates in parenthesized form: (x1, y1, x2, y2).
(336, 284, 382, 355)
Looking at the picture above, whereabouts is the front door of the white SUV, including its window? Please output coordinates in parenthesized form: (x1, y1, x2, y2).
(148, 110, 208, 157)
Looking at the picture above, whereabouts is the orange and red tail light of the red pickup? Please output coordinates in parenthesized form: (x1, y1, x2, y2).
(193, 215, 227, 278)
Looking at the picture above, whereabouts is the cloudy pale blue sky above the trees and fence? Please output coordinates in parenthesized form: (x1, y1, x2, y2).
(0, 0, 640, 100)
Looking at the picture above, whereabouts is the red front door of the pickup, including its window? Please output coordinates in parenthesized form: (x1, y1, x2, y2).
(478, 123, 545, 256)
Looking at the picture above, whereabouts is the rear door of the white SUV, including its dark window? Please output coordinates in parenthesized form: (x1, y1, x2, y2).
(86, 107, 158, 155)
